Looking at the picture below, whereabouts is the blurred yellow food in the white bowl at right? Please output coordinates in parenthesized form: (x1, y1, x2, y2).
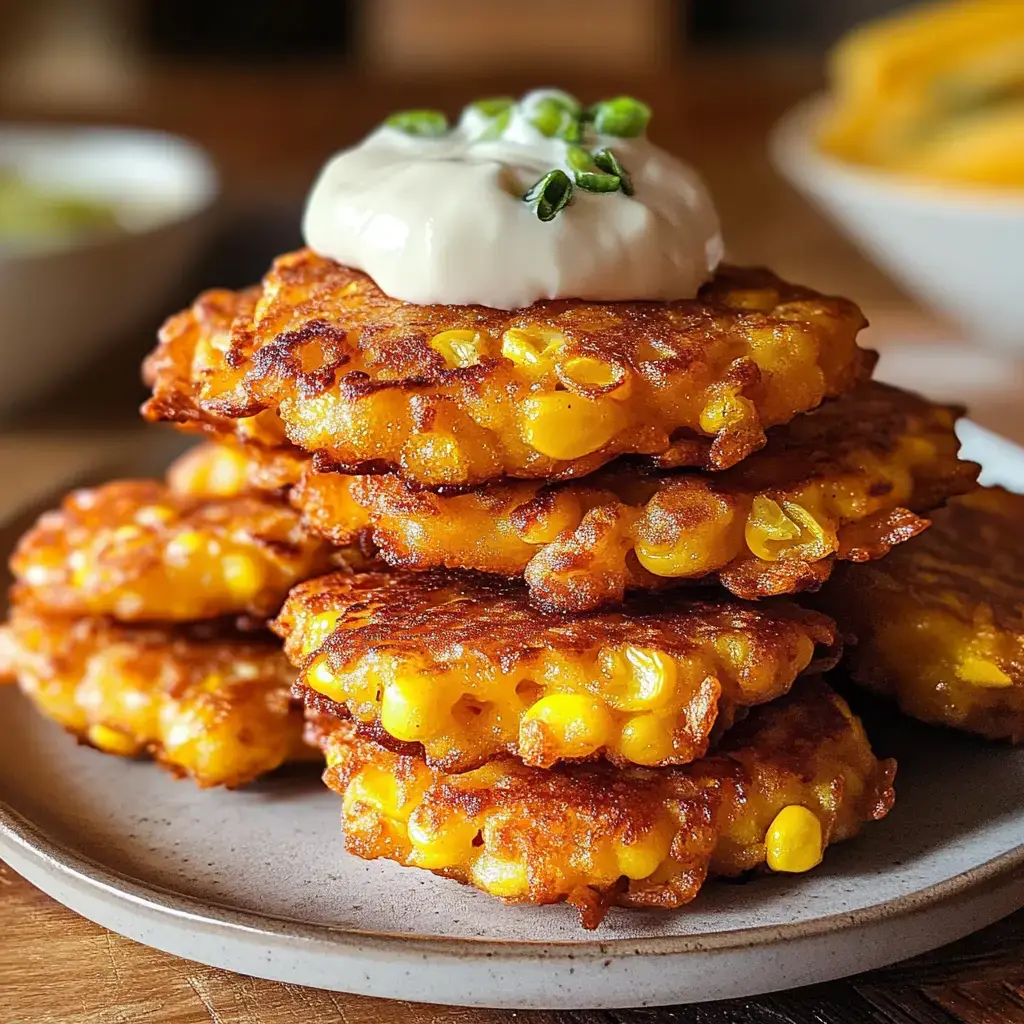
(819, 0, 1024, 187)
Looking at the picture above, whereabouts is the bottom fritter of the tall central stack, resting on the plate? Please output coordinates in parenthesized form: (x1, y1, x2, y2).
(311, 680, 896, 928)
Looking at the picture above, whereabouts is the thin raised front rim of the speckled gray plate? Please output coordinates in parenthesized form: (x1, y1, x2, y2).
(0, 782, 1024, 962)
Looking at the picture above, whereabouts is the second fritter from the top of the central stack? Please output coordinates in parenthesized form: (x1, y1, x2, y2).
(278, 383, 977, 611)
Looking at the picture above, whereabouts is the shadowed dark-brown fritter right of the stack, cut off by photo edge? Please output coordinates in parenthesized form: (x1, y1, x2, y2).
(817, 487, 1024, 741)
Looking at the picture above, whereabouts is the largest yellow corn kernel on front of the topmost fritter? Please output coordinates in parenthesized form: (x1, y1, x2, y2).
(522, 391, 624, 459)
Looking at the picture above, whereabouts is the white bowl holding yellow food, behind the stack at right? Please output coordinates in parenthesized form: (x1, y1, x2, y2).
(770, 97, 1024, 355)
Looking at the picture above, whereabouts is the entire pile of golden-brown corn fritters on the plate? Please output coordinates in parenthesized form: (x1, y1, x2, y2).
(3, 243, 1024, 927)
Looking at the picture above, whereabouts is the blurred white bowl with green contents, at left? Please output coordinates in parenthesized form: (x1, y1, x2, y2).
(0, 125, 218, 412)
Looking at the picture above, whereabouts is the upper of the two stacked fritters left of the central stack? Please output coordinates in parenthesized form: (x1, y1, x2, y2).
(11, 480, 340, 622)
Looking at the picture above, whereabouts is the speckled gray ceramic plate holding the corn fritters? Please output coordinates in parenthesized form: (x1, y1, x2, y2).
(0, 424, 1024, 1009)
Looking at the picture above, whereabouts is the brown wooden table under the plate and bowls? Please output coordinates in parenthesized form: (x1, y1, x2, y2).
(0, 59, 1024, 1024)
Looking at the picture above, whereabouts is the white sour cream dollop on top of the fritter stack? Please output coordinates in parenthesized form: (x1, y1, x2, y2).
(302, 90, 723, 309)
